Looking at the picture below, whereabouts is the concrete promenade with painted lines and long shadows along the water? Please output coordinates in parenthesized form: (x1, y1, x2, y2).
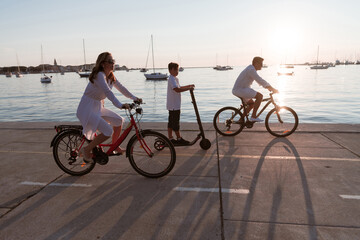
(0, 122, 360, 240)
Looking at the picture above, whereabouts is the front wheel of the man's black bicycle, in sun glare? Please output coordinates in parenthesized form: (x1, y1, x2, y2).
(265, 107, 299, 137)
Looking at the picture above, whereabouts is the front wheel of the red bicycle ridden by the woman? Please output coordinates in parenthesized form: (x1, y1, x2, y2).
(126, 130, 176, 178)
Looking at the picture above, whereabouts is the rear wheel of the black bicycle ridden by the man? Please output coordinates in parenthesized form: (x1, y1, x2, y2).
(213, 107, 245, 136)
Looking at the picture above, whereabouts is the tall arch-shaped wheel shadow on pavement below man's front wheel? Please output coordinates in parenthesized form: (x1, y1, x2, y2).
(239, 138, 318, 240)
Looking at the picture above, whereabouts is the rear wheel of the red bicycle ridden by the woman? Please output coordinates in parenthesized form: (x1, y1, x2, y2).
(53, 130, 95, 176)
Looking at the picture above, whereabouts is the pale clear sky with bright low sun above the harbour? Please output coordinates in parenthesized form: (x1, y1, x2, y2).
(0, 0, 360, 68)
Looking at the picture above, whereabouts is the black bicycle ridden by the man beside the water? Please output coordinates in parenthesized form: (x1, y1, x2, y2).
(213, 92, 299, 137)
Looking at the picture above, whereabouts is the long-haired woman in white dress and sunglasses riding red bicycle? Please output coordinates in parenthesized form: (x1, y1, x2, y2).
(76, 52, 142, 161)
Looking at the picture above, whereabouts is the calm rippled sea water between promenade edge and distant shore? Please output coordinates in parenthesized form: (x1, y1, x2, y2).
(0, 65, 360, 123)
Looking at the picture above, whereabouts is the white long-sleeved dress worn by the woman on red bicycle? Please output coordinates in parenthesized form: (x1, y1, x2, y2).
(76, 72, 137, 140)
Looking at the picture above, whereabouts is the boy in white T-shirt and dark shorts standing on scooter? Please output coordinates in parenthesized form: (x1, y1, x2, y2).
(166, 62, 195, 145)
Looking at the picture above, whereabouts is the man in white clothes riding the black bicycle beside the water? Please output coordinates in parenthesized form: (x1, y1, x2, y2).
(232, 57, 279, 122)
